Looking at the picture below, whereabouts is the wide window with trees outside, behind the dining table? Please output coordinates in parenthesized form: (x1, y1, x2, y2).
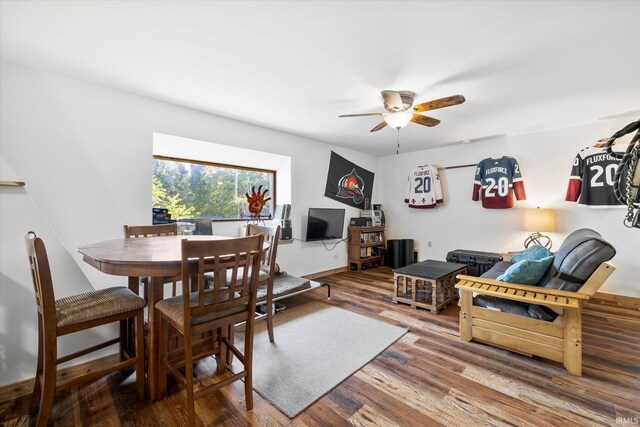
(153, 156, 276, 220)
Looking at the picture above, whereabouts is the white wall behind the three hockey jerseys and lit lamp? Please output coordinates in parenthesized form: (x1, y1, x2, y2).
(376, 119, 640, 296)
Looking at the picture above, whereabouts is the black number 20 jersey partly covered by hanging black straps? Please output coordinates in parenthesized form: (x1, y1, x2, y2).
(565, 146, 625, 206)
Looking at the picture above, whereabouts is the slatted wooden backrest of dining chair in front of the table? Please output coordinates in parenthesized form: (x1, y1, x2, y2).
(182, 235, 264, 325)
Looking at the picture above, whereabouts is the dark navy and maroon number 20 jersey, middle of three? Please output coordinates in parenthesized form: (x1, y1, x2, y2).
(473, 156, 527, 209)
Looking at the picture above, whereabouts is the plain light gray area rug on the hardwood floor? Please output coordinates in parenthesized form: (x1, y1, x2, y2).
(235, 297, 407, 418)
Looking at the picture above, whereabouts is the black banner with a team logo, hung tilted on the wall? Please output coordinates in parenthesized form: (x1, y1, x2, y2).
(324, 151, 375, 209)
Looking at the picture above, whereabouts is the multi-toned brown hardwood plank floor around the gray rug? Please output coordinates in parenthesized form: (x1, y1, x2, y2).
(0, 268, 640, 426)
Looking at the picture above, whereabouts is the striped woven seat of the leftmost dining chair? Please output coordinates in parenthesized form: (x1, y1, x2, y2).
(56, 286, 147, 328)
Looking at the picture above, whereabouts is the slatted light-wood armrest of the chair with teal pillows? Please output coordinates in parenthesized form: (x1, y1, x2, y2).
(456, 274, 589, 307)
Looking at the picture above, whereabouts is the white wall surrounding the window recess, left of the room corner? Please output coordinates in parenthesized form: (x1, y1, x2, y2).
(0, 62, 377, 384)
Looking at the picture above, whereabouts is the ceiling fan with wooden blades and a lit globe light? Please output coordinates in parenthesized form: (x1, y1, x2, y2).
(338, 90, 465, 132)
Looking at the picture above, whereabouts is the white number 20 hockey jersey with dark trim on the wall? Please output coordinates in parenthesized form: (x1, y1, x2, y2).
(404, 165, 444, 209)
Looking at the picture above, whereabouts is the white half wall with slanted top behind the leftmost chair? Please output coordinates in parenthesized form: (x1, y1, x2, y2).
(0, 156, 115, 384)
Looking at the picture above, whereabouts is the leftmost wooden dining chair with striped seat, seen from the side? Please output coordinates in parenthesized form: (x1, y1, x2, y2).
(25, 231, 146, 426)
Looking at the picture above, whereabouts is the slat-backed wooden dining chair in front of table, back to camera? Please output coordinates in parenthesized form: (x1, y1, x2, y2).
(155, 235, 264, 425)
